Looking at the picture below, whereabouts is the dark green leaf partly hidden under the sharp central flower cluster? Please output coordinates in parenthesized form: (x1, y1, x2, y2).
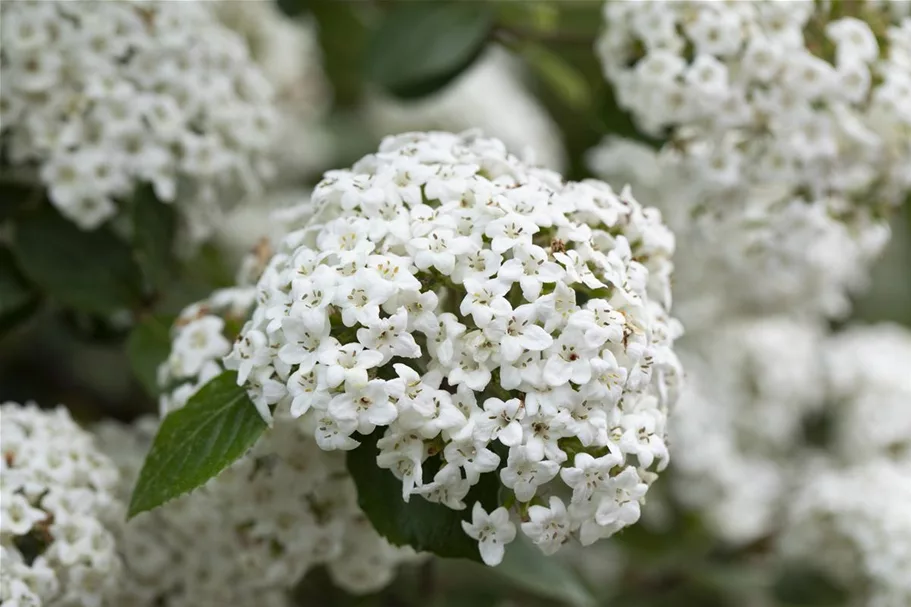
(348, 431, 500, 561)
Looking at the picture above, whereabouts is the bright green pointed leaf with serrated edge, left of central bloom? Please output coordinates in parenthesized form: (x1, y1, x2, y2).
(128, 371, 266, 518)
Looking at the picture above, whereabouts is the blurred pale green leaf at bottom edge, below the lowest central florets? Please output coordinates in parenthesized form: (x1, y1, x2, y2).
(493, 533, 597, 607)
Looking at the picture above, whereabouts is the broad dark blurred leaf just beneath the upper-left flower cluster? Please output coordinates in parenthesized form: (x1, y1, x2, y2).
(13, 207, 143, 315)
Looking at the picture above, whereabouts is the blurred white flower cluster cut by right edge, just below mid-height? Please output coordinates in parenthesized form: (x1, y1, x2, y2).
(825, 324, 911, 463)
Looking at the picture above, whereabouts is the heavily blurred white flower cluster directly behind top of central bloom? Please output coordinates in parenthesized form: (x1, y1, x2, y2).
(366, 48, 566, 171)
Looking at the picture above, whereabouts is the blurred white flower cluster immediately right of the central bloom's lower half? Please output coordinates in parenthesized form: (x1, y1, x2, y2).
(670, 317, 825, 544)
